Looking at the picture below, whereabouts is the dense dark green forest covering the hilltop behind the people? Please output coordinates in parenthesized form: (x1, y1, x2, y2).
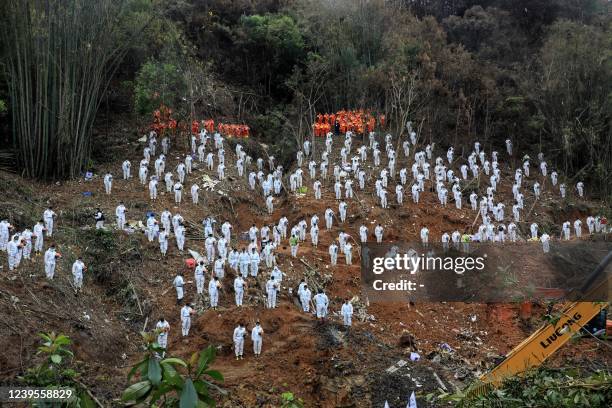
(0, 0, 612, 199)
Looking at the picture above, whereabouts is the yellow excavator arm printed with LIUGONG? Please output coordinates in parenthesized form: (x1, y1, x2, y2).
(467, 251, 612, 396)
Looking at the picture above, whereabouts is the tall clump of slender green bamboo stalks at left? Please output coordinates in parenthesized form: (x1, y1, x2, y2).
(0, 0, 143, 179)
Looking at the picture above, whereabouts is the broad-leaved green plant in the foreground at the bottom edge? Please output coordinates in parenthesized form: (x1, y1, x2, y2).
(122, 332, 225, 408)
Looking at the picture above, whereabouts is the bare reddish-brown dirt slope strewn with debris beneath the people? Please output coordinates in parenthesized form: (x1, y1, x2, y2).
(0, 128, 612, 407)
